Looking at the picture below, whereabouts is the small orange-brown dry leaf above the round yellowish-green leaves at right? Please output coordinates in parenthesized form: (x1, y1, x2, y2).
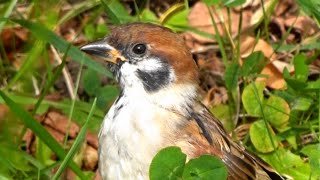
(256, 63, 285, 89)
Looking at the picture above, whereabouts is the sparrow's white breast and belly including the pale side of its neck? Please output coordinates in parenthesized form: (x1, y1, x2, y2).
(99, 82, 198, 180)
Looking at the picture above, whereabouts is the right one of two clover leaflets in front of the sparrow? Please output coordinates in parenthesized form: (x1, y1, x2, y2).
(182, 155, 228, 180)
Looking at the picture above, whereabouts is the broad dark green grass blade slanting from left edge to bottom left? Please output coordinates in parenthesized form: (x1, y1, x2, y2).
(0, 91, 85, 179)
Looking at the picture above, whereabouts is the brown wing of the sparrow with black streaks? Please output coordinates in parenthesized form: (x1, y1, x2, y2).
(177, 104, 282, 180)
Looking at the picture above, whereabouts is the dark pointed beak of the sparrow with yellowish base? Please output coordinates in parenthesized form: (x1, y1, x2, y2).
(80, 40, 126, 64)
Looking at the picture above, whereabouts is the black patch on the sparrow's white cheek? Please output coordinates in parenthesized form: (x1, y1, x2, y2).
(136, 65, 170, 92)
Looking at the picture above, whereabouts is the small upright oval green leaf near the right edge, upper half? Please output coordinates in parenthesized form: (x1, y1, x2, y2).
(293, 54, 309, 82)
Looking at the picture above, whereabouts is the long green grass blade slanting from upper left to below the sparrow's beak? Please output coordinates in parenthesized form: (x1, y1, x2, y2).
(11, 19, 113, 78)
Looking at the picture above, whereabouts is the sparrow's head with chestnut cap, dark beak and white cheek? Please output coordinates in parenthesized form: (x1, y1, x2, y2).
(81, 23, 198, 107)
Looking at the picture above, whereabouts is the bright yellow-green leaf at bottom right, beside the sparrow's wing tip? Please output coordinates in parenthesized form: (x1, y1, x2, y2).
(259, 148, 311, 180)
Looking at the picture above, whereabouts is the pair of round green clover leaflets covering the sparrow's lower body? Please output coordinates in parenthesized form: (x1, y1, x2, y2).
(149, 147, 228, 180)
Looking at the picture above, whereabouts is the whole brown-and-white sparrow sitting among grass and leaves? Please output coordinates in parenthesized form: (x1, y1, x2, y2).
(81, 23, 282, 180)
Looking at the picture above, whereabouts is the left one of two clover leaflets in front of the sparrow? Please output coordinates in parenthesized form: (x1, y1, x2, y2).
(149, 147, 187, 180)
